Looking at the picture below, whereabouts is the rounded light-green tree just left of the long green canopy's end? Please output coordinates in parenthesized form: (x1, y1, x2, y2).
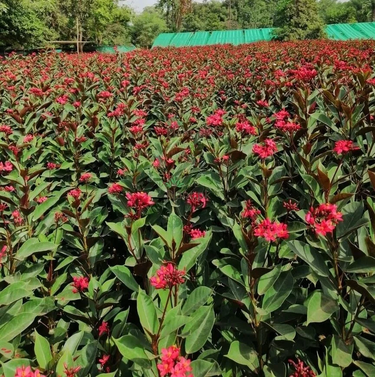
(131, 7, 168, 47)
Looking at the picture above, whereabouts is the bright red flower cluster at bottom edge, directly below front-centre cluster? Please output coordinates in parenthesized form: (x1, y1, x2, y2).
(158, 346, 193, 377)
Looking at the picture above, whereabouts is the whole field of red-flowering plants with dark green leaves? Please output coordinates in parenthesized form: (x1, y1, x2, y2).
(0, 41, 375, 377)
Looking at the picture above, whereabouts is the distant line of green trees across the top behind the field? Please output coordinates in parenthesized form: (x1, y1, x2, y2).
(0, 0, 375, 49)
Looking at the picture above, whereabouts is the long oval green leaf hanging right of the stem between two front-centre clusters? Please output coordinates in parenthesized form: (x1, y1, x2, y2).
(185, 307, 215, 354)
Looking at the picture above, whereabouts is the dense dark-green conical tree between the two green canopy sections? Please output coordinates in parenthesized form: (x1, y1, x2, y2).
(275, 0, 325, 41)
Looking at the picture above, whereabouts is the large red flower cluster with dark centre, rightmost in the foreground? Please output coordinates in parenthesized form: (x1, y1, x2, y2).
(305, 203, 343, 236)
